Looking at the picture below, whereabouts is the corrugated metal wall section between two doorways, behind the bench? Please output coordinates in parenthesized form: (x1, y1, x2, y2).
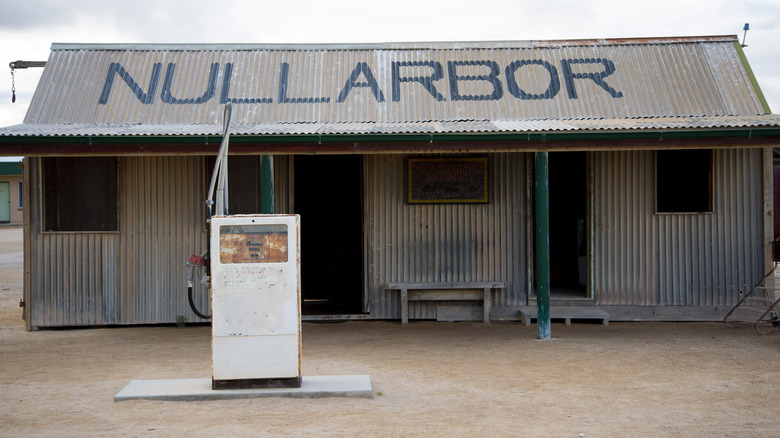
(364, 154, 527, 318)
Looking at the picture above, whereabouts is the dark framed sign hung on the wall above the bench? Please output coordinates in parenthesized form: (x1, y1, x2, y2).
(406, 156, 489, 204)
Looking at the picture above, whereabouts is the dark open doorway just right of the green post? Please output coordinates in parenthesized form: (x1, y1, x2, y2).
(548, 152, 588, 299)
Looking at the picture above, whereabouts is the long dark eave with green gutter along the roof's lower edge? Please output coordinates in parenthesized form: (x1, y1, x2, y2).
(0, 127, 780, 156)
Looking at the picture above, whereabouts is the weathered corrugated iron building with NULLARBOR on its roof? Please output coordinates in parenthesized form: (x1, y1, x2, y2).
(0, 36, 780, 328)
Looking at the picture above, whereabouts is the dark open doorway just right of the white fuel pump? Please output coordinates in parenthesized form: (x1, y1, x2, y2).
(293, 155, 363, 314)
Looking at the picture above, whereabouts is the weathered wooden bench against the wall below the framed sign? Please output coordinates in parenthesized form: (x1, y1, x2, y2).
(387, 282, 506, 324)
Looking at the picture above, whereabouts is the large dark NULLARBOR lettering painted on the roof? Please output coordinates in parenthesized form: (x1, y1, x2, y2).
(98, 58, 623, 105)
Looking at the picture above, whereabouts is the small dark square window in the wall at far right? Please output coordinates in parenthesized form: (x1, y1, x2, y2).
(655, 149, 714, 213)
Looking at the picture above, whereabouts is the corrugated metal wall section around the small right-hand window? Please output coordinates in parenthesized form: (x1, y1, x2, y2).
(591, 149, 763, 306)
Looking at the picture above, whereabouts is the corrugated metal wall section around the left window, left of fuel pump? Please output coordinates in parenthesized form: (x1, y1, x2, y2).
(29, 157, 210, 327)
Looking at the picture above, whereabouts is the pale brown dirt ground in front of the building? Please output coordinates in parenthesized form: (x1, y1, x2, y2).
(0, 227, 780, 437)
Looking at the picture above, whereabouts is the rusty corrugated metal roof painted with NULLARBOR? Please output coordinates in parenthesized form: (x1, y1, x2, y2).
(0, 36, 780, 136)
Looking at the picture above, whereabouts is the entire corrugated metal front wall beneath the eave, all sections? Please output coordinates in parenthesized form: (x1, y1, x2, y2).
(27, 149, 763, 327)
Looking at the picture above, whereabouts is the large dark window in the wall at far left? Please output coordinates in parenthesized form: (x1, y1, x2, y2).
(43, 157, 119, 231)
